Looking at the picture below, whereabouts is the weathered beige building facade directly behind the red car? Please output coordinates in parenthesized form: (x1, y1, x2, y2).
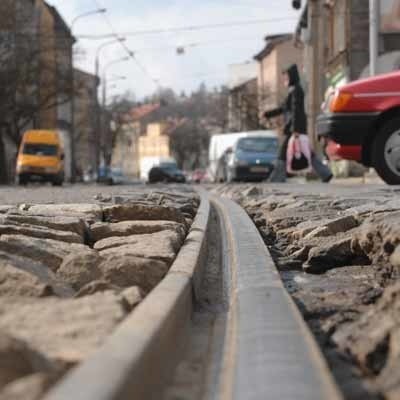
(295, 0, 400, 175)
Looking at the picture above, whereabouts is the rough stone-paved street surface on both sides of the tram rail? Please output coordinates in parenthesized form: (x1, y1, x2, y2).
(0, 181, 400, 400)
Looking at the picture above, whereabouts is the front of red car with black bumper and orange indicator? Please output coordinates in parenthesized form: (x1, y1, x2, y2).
(317, 72, 400, 185)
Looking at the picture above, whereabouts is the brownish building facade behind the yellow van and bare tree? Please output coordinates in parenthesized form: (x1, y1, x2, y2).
(0, 0, 74, 178)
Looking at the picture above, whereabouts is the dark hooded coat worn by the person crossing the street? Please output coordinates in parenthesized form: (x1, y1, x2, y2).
(264, 64, 307, 136)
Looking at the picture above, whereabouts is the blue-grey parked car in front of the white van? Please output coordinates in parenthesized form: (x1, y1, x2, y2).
(225, 132, 278, 182)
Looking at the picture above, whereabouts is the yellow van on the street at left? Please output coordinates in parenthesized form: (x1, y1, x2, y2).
(16, 130, 64, 186)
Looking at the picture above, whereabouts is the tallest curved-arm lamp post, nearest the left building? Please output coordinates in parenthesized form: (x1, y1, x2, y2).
(70, 8, 107, 183)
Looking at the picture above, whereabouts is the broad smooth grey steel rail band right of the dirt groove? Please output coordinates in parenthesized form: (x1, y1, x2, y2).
(211, 197, 343, 400)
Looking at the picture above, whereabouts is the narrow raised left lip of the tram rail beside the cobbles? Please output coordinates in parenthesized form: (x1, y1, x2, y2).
(44, 191, 210, 400)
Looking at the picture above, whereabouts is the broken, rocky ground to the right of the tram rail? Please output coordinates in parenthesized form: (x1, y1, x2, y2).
(217, 185, 400, 400)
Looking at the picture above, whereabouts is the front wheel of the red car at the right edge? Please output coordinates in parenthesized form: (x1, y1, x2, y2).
(372, 117, 400, 185)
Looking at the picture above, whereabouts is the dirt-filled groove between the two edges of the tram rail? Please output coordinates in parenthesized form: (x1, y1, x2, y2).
(163, 206, 228, 400)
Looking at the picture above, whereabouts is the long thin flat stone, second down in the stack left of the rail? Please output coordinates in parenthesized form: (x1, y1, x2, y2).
(90, 221, 186, 242)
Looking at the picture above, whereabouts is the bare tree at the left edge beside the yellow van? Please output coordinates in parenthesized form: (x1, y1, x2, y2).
(0, 0, 74, 183)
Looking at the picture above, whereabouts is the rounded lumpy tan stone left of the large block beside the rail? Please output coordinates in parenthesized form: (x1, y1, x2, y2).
(57, 250, 102, 291)
